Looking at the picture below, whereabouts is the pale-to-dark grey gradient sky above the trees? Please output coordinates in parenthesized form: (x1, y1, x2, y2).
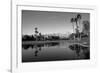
(22, 10, 90, 35)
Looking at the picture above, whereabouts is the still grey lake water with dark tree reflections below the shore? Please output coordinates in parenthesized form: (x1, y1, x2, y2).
(22, 41, 90, 62)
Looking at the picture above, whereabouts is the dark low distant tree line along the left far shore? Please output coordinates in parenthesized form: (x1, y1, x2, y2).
(22, 35, 67, 41)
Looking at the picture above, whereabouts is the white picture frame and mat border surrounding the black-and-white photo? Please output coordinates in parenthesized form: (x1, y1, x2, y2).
(11, 1, 97, 73)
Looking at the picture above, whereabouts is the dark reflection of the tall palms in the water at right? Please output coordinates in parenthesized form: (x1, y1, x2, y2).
(69, 44, 90, 59)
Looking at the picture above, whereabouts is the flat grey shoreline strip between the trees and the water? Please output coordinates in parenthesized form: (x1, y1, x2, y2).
(22, 39, 90, 47)
